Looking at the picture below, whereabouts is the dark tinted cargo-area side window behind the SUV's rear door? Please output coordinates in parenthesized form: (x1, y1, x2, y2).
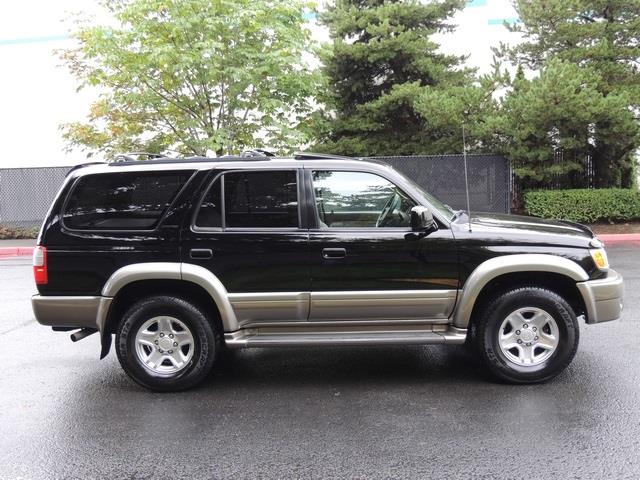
(63, 170, 193, 230)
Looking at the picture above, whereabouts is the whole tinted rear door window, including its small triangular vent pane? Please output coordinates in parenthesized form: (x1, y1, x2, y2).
(196, 170, 298, 228)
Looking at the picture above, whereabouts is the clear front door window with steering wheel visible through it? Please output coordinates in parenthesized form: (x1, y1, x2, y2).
(313, 170, 416, 228)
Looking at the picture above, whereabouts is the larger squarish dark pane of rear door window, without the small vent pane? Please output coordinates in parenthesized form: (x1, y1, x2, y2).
(224, 171, 298, 228)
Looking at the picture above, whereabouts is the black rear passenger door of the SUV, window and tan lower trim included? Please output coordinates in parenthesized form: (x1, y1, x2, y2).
(182, 168, 310, 326)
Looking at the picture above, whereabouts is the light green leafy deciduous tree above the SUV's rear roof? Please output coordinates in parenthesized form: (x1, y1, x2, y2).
(62, 0, 315, 156)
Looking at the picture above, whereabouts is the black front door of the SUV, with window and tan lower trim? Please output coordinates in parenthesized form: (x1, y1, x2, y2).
(307, 169, 458, 323)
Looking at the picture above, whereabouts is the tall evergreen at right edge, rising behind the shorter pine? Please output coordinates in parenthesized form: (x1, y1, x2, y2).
(502, 0, 640, 187)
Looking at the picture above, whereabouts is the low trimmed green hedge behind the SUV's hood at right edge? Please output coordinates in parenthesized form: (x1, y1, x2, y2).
(524, 188, 640, 223)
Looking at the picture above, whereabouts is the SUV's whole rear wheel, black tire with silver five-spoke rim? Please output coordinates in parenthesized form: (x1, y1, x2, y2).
(116, 295, 221, 392)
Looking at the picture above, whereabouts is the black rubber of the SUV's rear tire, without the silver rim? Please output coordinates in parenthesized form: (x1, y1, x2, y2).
(116, 295, 221, 392)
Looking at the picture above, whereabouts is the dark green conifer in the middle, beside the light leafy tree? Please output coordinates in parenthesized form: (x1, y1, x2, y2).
(313, 0, 493, 155)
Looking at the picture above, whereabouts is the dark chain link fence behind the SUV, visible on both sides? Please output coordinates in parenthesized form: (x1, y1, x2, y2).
(0, 155, 511, 228)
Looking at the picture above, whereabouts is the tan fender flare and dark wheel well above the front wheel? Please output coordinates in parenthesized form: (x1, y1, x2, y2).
(453, 254, 589, 328)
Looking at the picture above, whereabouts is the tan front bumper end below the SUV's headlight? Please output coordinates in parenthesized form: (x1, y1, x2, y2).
(576, 270, 624, 324)
